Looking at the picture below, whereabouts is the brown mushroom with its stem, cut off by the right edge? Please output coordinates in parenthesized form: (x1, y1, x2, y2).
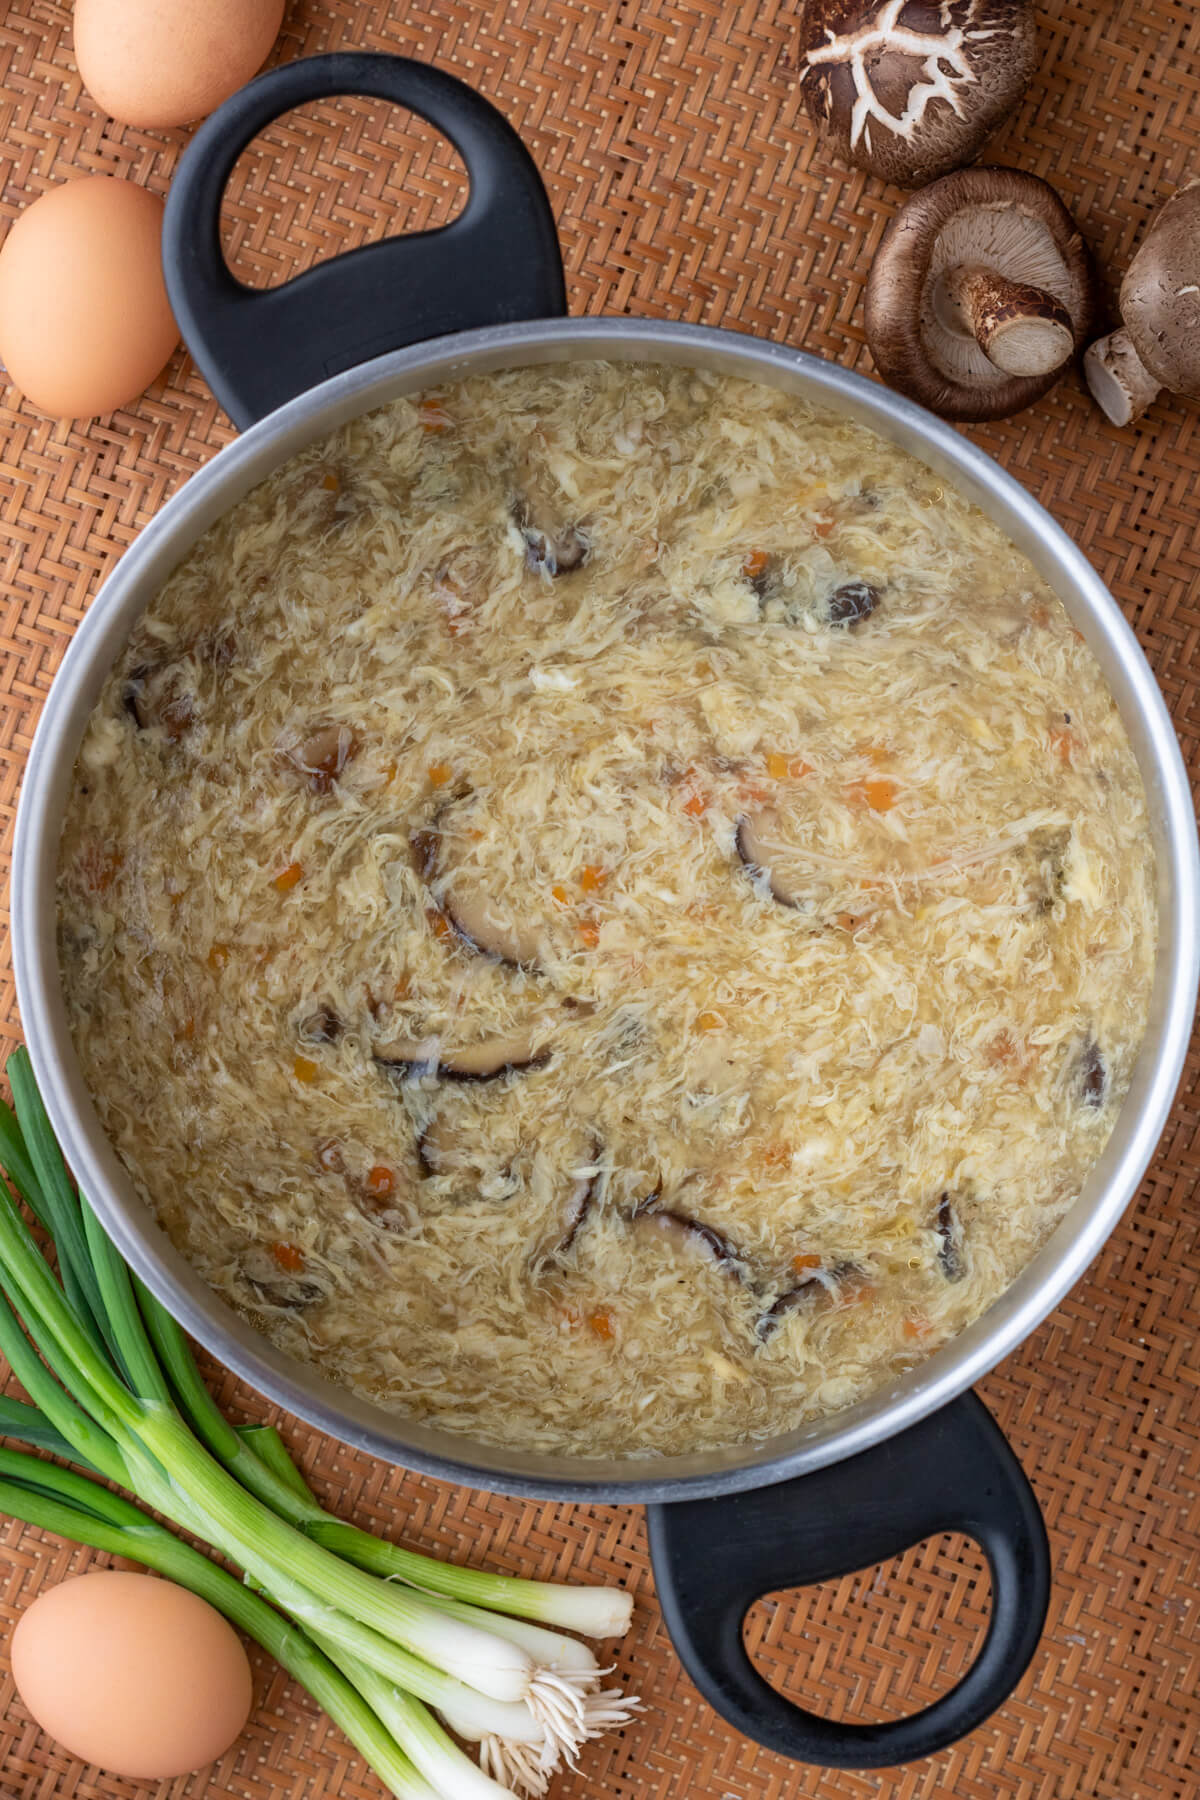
(1083, 180, 1200, 425)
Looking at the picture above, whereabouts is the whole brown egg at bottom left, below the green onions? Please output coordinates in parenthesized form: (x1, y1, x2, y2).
(13, 1570, 254, 1780)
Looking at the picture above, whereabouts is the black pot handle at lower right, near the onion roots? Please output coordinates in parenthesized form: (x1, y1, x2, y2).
(648, 1393, 1051, 1769)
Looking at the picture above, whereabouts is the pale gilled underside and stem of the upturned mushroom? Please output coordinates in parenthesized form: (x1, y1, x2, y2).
(921, 203, 1076, 383)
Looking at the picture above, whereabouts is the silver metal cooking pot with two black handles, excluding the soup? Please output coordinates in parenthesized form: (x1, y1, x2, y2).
(13, 56, 1198, 1768)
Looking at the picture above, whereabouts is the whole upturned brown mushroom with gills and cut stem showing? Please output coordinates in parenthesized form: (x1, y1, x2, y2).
(865, 169, 1097, 419)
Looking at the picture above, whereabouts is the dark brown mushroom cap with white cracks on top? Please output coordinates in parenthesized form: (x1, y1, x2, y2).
(799, 0, 1038, 187)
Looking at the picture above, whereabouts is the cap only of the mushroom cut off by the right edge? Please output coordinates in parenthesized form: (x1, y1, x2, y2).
(1121, 180, 1200, 396)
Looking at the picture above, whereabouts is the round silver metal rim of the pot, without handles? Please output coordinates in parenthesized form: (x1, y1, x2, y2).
(13, 319, 1200, 1503)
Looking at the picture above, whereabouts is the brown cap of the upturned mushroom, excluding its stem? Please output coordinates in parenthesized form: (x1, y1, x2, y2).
(867, 167, 1097, 419)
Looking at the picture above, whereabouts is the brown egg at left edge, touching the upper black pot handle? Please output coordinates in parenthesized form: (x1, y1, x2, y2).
(0, 175, 180, 419)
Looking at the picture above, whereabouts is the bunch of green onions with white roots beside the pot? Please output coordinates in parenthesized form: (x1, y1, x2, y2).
(0, 1051, 637, 1800)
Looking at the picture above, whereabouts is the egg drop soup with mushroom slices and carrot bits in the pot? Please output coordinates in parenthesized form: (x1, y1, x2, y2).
(59, 362, 1155, 1456)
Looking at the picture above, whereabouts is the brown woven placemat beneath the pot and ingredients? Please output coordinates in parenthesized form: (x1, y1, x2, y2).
(0, 0, 1200, 1800)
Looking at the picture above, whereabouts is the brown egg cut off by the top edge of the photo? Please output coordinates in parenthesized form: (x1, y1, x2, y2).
(76, 0, 284, 126)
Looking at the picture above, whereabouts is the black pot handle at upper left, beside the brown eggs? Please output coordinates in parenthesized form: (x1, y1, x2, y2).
(162, 54, 567, 427)
